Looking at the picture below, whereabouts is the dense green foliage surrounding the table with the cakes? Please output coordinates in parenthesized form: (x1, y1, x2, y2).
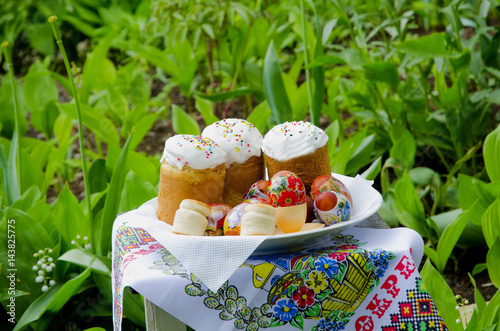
(0, 0, 500, 330)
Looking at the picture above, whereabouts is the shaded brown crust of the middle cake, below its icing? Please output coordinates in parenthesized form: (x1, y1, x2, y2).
(222, 155, 265, 207)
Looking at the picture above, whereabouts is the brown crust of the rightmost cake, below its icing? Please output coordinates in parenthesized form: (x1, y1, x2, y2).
(264, 144, 331, 192)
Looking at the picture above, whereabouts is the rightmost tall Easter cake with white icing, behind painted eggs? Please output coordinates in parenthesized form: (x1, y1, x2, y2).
(262, 121, 331, 191)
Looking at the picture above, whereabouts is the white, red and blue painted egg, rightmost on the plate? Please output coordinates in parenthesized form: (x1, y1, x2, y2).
(314, 191, 351, 226)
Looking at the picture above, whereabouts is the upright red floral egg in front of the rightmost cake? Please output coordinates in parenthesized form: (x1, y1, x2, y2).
(267, 171, 306, 207)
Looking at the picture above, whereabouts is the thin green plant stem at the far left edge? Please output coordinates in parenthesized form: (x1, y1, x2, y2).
(2, 41, 22, 203)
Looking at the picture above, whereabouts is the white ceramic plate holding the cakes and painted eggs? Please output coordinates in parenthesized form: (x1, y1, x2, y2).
(253, 174, 383, 255)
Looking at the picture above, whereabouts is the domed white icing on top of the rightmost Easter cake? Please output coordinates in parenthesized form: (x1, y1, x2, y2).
(262, 121, 328, 161)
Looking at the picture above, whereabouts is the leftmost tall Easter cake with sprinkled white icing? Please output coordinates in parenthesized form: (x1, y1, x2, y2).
(156, 135, 226, 225)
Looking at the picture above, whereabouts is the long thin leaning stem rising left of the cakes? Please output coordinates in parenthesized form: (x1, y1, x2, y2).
(49, 16, 96, 236)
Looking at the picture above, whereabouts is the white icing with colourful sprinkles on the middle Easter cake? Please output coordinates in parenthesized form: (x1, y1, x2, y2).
(201, 118, 263, 168)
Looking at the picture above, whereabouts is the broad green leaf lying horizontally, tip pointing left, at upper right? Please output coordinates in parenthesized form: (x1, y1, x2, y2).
(396, 32, 454, 58)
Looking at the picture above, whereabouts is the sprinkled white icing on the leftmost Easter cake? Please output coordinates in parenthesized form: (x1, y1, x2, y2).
(160, 134, 226, 170)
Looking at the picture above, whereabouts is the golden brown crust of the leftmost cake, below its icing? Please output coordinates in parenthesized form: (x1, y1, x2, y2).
(156, 162, 226, 225)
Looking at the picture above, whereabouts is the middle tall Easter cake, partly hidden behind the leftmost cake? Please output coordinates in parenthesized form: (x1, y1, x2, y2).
(202, 118, 265, 207)
